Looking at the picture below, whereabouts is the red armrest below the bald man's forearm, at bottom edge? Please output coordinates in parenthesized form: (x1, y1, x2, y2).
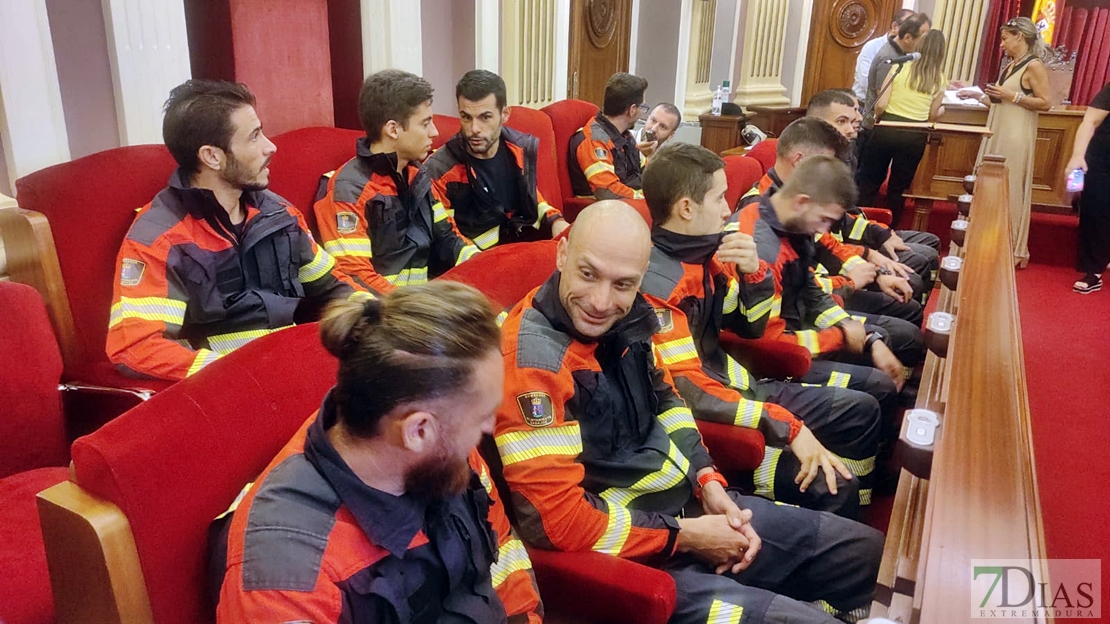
(528, 548, 675, 624)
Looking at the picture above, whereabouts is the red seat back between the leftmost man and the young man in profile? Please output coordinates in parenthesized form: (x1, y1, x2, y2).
(270, 127, 364, 231)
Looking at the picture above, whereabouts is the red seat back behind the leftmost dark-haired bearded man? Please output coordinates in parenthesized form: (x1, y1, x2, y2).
(16, 145, 176, 379)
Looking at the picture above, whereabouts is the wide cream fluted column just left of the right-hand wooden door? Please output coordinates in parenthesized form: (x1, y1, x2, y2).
(733, 0, 797, 105)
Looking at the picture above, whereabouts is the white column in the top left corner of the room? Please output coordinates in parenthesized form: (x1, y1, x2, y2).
(0, 0, 70, 189)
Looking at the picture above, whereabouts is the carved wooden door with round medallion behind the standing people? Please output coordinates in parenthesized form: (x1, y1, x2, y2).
(801, 0, 901, 105)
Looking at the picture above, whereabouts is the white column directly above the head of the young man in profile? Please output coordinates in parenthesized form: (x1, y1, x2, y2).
(362, 0, 424, 76)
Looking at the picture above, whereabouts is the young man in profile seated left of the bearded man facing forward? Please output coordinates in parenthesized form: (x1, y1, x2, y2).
(315, 69, 480, 292)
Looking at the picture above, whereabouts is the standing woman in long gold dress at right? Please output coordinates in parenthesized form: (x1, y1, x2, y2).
(958, 18, 1052, 268)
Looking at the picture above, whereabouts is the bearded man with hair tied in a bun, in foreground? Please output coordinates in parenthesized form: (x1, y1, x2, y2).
(210, 281, 543, 624)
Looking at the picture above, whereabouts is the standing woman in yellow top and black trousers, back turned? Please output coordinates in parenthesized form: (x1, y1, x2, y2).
(859, 30, 948, 228)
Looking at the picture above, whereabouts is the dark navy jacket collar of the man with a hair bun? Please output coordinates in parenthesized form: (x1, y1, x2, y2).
(304, 392, 426, 557)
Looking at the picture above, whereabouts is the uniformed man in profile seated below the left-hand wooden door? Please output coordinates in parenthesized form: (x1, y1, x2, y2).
(567, 72, 647, 200)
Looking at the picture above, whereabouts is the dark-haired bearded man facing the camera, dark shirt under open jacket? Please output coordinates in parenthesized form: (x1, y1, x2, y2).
(425, 69, 569, 249)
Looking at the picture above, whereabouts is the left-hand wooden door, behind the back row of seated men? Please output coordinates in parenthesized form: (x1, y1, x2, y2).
(567, 0, 632, 107)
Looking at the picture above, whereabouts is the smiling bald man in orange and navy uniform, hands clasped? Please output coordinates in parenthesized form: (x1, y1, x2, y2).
(495, 201, 882, 624)
